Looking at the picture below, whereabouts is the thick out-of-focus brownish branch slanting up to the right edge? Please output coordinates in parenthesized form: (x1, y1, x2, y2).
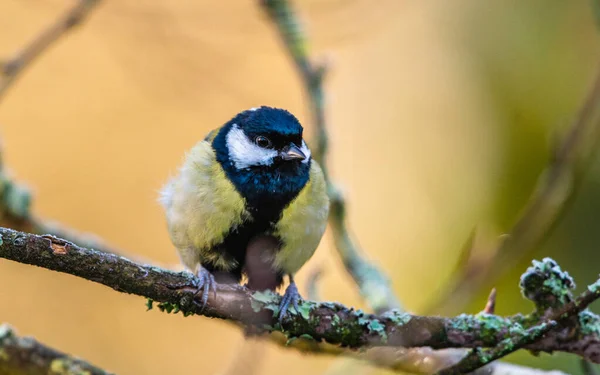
(428, 63, 600, 312)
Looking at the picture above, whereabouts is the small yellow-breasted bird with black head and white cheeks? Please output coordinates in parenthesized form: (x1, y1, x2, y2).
(159, 106, 329, 322)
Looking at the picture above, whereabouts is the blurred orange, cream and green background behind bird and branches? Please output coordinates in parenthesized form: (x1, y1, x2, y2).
(0, 0, 600, 375)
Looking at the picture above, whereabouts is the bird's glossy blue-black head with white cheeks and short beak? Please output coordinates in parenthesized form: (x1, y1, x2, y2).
(212, 106, 311, 212)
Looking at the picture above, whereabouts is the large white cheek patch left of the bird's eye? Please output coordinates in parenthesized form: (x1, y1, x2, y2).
(226, 124, 277, 169)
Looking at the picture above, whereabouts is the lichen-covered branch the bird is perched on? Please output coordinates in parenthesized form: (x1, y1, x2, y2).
(0, 228, 600, 363)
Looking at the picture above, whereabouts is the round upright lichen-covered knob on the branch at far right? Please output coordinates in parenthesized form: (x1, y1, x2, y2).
(520, 258, 575, 312)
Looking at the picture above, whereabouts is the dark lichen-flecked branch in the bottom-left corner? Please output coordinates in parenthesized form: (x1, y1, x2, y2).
(0, 324, 111, 375)
